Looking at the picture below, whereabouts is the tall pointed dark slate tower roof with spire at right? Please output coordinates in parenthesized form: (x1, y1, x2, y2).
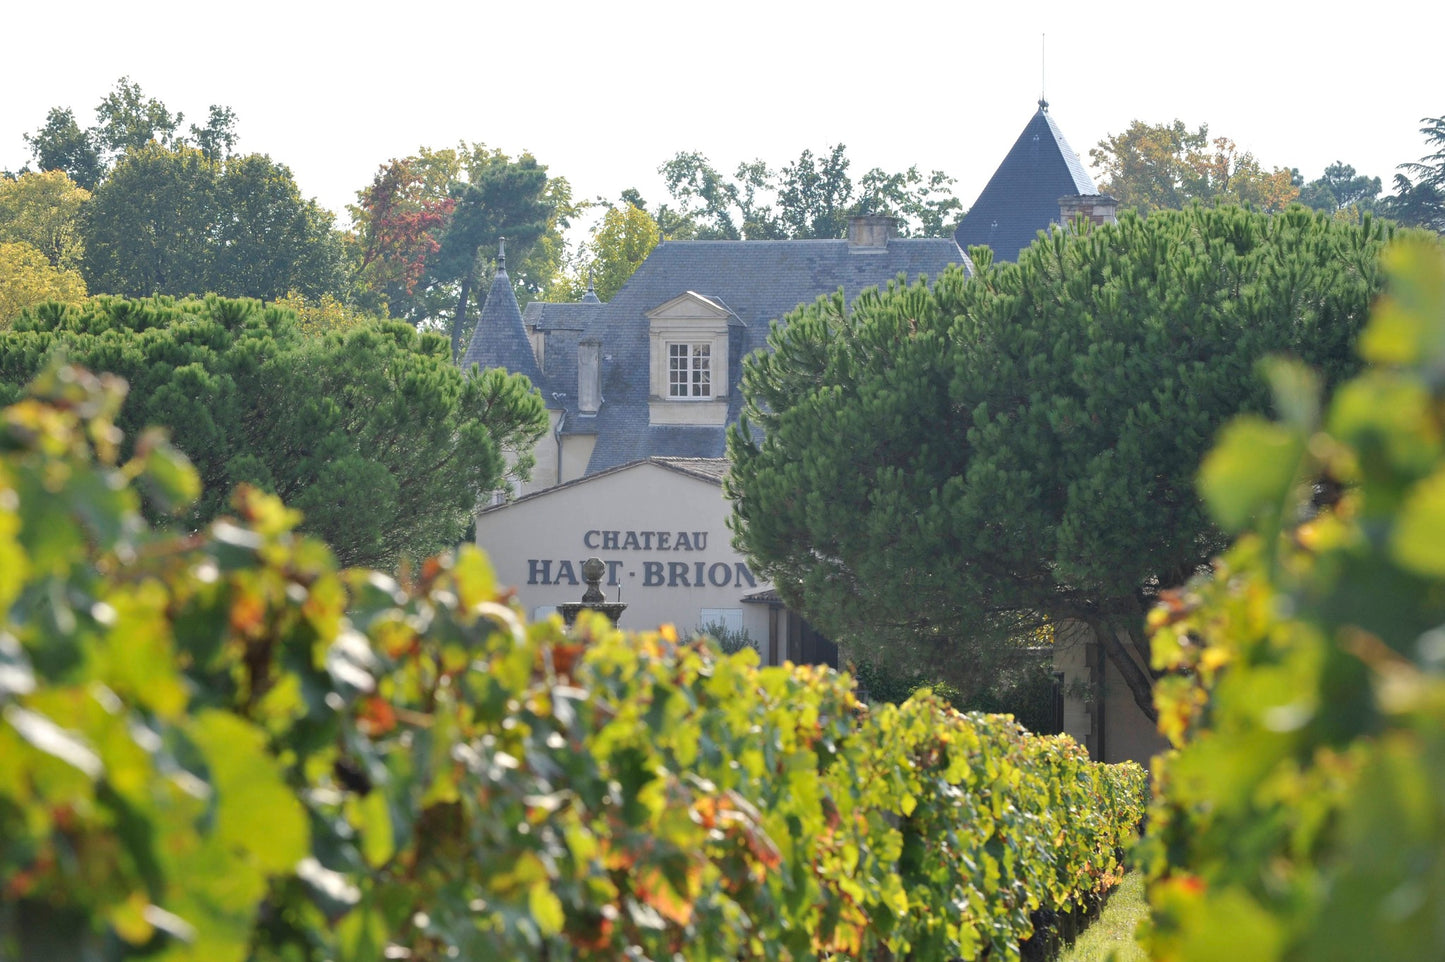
(954, 100, 1098, 261)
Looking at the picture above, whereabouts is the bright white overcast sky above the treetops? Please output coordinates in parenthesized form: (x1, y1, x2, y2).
(0, 0, 1445, 232)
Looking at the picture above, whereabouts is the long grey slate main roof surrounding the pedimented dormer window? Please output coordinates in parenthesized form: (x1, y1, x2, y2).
(508, 238, 972, 474)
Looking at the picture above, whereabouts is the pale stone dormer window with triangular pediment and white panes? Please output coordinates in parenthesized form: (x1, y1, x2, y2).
(647, 290, 741, 425)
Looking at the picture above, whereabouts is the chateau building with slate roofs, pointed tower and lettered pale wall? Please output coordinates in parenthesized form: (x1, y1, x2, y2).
(462, 101, 1161, 753)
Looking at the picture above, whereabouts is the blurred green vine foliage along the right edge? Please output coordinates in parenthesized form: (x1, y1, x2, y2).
(1146, 241, 1445, 962)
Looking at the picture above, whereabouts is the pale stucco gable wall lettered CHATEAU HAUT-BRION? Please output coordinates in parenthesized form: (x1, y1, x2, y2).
(477, 462, 769, 651)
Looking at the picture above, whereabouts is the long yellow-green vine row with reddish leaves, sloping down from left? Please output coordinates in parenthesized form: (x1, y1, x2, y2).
(0, 368, 1144, 962)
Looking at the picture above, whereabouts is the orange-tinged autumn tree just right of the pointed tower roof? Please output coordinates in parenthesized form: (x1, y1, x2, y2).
(1088, 120, 1299, 214)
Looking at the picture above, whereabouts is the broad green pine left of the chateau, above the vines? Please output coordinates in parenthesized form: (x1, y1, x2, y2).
(0, 298, 546, 566)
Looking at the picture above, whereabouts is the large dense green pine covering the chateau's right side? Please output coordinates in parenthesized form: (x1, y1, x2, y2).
(727, 207, 1389, 716)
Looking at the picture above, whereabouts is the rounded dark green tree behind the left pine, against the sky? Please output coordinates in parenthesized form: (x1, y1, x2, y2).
(82, 143, 347, 299)
